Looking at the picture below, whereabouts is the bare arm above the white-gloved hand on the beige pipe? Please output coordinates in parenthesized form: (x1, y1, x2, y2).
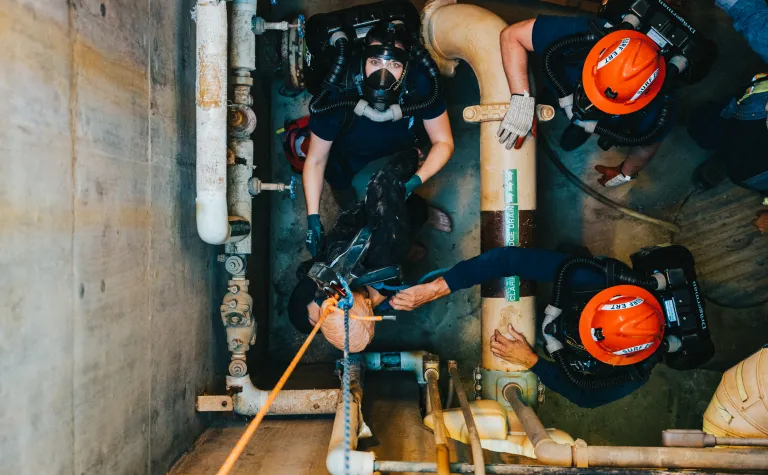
(501, 18, 536, 94)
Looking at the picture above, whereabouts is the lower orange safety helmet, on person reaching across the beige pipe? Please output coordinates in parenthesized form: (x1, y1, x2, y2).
(579, 285, 665, 366)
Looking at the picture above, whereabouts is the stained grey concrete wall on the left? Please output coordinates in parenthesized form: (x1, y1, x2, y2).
(0, 0, 217, 474)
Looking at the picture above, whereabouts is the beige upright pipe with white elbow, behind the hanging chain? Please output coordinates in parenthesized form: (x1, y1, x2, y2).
(325, 362, 374, 475)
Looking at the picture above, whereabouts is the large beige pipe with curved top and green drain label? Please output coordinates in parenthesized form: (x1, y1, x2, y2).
(422, 0, 536, 371)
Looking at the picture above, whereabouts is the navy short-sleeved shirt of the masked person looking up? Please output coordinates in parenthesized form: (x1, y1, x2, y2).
(309, 64, 445, 189)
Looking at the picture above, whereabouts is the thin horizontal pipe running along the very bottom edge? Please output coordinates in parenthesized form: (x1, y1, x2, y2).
(373, 460, 727, 475)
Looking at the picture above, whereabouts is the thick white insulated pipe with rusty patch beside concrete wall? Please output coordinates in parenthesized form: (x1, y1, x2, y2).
(195, 0, 231, 244)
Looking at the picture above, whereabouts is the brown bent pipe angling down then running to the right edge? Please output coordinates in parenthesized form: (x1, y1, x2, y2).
(504, 387, 768, 470)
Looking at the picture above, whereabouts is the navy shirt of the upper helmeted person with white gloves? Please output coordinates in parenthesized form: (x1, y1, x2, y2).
(532, 15, 677, 142)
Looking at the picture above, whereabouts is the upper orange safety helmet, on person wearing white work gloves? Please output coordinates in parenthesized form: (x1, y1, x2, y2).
(581, 30, 667, 115)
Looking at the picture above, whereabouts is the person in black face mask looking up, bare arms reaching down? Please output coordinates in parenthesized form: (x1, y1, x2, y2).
(302, 7, 453, 256)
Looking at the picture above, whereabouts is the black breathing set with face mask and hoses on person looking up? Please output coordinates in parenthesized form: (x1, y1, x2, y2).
(305, 0, 440, 122)
